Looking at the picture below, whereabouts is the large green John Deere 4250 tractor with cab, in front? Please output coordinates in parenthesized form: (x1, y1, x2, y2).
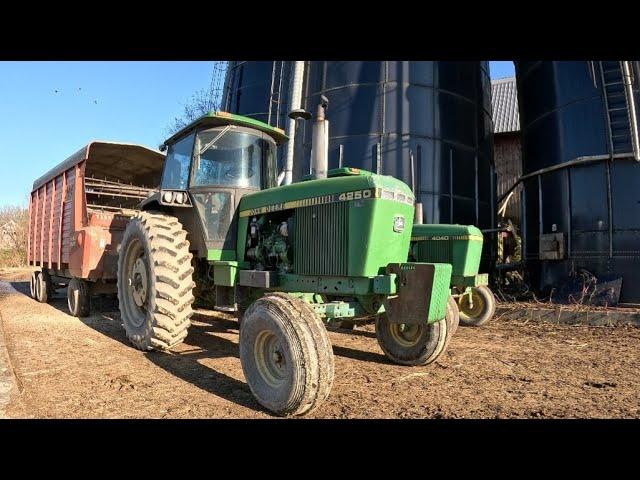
(118, 102, 457, 416)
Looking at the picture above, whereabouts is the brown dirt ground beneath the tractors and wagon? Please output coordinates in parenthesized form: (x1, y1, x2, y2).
(0, 270, 640, 418)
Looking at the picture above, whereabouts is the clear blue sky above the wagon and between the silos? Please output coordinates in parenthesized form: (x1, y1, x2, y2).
(0, 61, 513, 206)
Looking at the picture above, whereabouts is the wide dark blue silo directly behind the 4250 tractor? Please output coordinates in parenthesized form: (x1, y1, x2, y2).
(223, 61, 495, 260)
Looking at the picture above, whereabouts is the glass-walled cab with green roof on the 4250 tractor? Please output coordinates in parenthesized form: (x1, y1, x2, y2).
(147, 112, 287, 260)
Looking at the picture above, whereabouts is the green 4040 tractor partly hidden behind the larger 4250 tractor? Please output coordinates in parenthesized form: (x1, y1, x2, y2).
(409, 224, 496, 326)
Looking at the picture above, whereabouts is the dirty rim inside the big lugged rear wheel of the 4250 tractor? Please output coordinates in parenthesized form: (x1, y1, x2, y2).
(125, 240, 149, 327)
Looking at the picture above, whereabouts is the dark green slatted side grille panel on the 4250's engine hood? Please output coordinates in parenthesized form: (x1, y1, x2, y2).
(294, 202, 349, 276)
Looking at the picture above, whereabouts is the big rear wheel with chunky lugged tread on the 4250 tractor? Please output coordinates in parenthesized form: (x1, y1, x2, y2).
(118, 212, 195, 350)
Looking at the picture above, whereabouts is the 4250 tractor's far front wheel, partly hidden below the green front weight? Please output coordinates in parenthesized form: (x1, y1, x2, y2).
(376, 313, 450, 365)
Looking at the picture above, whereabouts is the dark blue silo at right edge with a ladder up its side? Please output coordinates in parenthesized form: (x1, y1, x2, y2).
(516, 61, 640, 303)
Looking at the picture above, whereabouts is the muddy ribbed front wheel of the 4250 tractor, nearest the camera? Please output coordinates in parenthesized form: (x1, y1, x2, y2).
(240, 293, 334, 416)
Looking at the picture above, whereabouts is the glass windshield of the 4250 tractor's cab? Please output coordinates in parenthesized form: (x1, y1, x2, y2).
(191, 126, 275, 189)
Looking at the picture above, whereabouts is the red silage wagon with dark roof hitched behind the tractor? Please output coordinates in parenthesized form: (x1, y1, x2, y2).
(28, 141, 164, 316)
